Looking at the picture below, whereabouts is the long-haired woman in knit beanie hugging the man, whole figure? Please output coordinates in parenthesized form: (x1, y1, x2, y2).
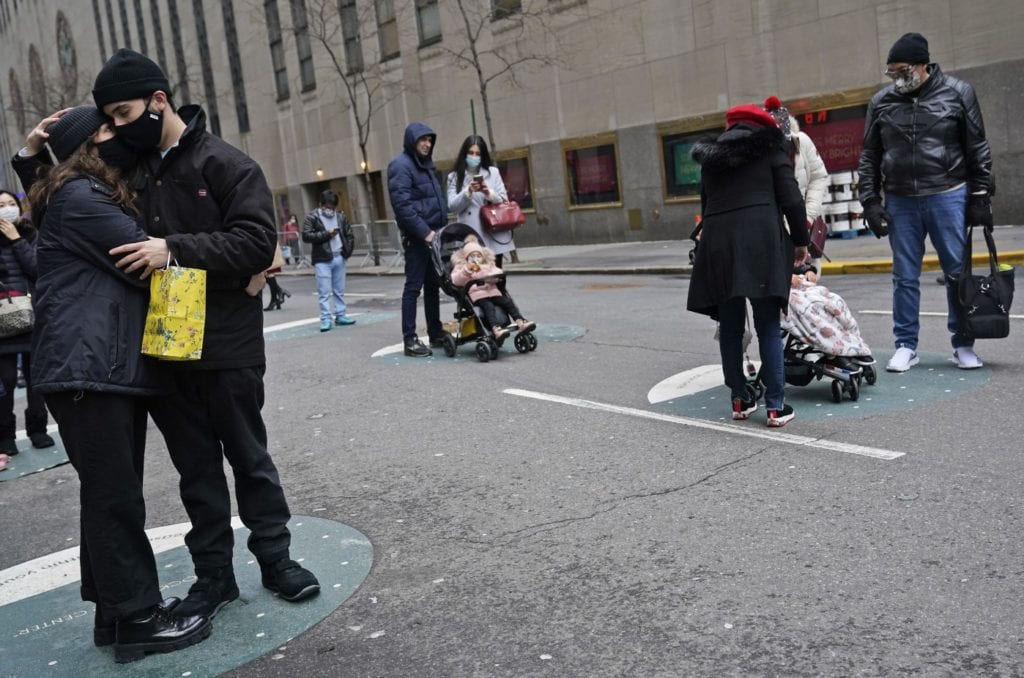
(29, 105, 210, 663)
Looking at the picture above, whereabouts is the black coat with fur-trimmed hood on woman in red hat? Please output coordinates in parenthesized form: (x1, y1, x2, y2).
(686, 123, 809, 317)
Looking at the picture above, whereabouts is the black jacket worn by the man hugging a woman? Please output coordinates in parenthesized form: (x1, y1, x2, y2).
(133, 105, 278, 370)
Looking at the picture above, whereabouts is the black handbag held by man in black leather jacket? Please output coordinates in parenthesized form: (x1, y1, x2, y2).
(949, 226, 1016, 339)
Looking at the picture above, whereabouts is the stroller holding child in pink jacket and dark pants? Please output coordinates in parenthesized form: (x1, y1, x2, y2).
(431, 223, 537, 363)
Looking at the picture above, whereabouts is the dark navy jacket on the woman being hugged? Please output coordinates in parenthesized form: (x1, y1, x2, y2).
(32, 176, 167, 395)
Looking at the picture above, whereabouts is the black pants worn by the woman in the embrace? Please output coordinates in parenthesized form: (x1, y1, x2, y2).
(45, 391, 161, 618)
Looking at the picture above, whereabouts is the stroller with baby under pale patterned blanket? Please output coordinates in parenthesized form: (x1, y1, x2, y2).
(782, 264, 877, 402)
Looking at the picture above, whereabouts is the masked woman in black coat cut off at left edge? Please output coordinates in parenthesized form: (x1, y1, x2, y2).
(0, 188, 53, 455)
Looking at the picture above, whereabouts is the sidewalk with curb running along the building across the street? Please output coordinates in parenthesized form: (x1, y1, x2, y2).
(285, 225, 1024, 276)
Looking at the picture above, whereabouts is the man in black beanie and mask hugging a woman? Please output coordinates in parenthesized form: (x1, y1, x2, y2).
(92, 49, 319, 618)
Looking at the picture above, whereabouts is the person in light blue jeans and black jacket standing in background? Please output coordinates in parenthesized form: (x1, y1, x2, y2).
(302, 190, 355, 332)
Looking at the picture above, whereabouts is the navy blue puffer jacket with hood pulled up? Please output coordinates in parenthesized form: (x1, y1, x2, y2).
(387, 123, 447, 241)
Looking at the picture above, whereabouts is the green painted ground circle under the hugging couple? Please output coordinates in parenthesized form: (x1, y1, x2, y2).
(0, 515, 373, 677)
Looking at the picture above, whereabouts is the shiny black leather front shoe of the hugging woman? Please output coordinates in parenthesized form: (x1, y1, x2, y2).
(114, 605, 213, 664)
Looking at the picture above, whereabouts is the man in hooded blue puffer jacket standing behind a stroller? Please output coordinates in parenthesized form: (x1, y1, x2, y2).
(387, 122, 447, 357)
